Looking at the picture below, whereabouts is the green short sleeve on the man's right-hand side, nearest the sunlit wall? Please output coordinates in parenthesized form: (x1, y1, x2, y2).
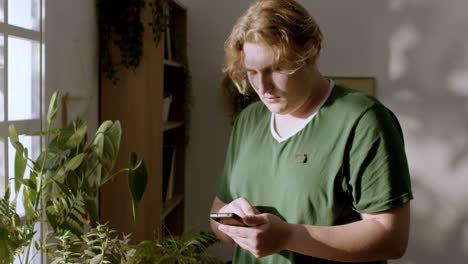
(348, 104, 413, 213)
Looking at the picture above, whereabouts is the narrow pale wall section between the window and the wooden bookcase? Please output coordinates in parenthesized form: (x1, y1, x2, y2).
(45, 0, 98, 136)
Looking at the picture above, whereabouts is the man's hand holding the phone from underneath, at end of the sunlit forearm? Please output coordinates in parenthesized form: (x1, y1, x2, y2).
(218, 214, 290, 258)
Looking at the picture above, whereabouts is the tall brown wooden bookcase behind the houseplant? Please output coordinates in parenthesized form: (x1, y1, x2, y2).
(99, 0, 189, 242)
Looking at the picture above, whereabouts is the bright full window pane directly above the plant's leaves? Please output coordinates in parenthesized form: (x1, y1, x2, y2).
(8, 36, 40, 120)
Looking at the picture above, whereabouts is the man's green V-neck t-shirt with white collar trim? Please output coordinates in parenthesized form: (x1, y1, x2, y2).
(216, 86, 413, 264)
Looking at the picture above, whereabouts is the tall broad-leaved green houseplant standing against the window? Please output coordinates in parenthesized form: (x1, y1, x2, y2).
(0, 92, 147, 264)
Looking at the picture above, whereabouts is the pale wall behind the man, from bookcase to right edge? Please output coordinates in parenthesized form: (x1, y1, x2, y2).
(181, 0, 468, 264)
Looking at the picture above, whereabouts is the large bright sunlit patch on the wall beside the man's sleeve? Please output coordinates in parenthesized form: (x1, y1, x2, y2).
(399, 115, 468, 251)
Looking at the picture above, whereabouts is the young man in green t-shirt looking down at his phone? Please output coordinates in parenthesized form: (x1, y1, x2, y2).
(211, 0, 413, 264)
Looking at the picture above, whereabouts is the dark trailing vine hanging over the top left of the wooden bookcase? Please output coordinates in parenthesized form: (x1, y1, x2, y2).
(96, 0, 169, 84)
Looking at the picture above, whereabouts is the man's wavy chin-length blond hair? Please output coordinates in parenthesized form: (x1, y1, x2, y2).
(223, 0, 323, 94)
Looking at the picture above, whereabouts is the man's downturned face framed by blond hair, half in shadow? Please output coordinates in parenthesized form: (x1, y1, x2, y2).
(243, 42, 312, 115)
